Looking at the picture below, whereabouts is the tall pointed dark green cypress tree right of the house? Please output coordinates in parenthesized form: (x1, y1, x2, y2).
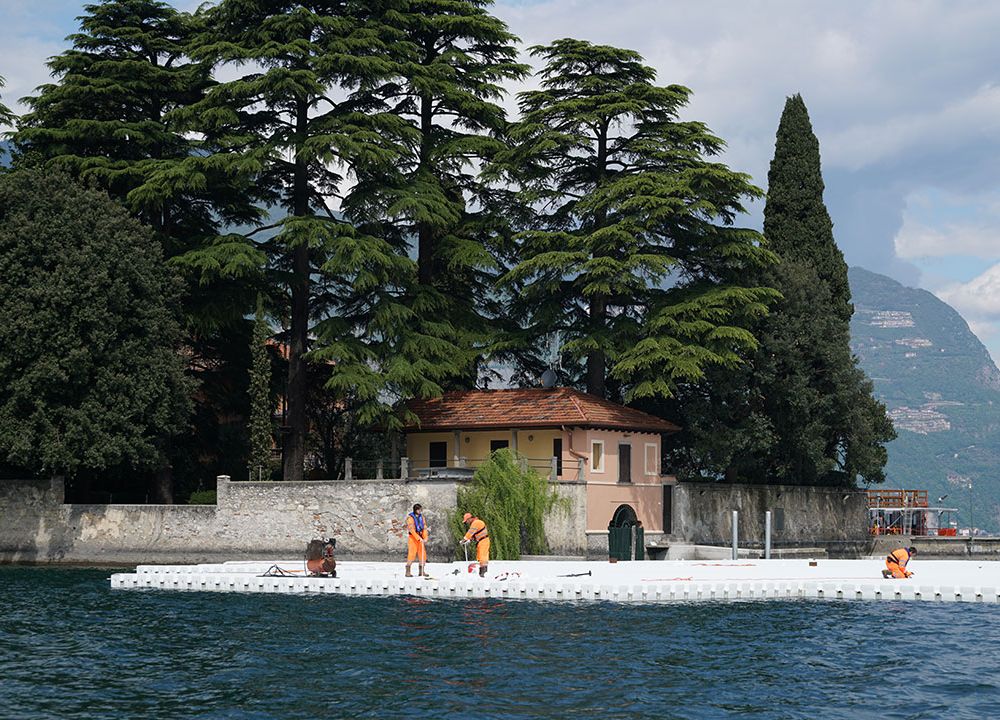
(745, 95, 895, 485)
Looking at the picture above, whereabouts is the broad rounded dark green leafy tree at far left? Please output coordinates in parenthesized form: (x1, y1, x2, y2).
(0, 170, 191, 475)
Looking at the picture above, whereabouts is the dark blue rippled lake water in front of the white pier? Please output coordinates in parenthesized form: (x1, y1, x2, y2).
(0, 567, 1000, 720)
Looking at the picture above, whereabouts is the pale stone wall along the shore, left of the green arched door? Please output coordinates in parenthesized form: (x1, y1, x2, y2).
(0, 478, 586, 564)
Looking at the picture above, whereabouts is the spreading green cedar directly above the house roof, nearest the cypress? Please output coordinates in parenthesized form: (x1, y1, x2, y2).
(491, 39, 774, 399)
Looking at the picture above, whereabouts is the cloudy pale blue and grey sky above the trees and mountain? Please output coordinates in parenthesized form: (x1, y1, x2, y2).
(0, 0, 1000, 360)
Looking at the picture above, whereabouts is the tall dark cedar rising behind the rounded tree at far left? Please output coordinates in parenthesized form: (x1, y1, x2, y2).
(14, 0, 256, 498)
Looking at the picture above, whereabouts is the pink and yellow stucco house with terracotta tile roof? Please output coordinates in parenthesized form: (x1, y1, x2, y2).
(406, 387, 678, 532)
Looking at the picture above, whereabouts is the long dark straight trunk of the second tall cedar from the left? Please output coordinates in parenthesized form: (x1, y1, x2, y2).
(282, 101, 310, 481)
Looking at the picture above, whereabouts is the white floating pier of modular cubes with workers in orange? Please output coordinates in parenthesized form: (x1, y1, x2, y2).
(111, 558, 1000, 603)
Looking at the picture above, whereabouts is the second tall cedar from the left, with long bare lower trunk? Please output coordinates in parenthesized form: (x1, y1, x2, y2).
(177, 0, 404, 480)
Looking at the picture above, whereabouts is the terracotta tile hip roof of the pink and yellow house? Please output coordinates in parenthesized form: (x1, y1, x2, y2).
(407, 387, 680, 433)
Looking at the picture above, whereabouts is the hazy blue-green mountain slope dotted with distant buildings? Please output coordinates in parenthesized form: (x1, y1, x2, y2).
(850, 267, 1000, 531)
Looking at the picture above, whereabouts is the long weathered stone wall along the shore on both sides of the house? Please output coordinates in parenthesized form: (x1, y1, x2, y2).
(0, 478, 870, 565)
